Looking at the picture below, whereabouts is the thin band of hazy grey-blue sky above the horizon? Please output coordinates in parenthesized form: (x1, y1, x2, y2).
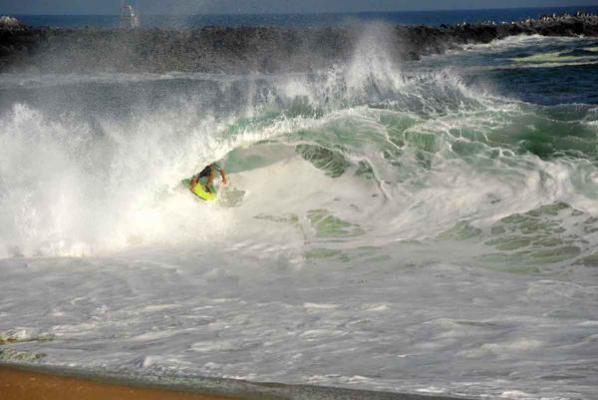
(0, 0, 598, 15)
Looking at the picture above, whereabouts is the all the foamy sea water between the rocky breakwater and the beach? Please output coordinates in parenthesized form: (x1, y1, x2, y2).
(0, 25, 598, 399)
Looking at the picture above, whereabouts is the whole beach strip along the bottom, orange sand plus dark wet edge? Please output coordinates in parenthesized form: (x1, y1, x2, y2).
(0, 362, 465, 400)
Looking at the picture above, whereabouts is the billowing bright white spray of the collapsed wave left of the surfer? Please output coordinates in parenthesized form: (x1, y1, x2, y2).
(0, 101, 238, 256)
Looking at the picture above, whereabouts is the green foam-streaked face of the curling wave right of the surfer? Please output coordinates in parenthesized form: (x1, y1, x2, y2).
(224, 103, 598, 272)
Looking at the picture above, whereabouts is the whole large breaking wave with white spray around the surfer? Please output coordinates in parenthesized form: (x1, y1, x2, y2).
(0, 33, 598, 276)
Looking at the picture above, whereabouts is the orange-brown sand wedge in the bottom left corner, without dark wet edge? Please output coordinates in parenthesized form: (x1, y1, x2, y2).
(0, 366, 241, 400)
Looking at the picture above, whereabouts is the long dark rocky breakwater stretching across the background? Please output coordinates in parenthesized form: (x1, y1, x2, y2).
(0, 13, 598, 73)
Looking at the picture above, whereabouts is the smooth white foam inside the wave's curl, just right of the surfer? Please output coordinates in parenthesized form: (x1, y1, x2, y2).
(225, 156, 382, 255)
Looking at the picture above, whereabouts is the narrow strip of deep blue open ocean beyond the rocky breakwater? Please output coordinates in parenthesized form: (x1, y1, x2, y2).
(17, 6, 598, 28)
